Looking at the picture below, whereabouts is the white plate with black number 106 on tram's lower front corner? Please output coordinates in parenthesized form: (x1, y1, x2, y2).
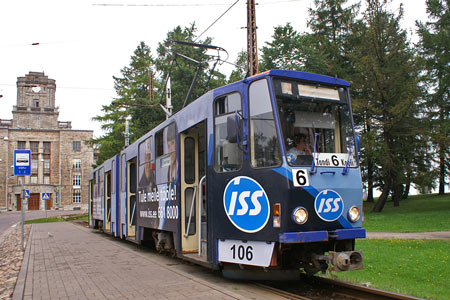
(218, 240, 275, 267)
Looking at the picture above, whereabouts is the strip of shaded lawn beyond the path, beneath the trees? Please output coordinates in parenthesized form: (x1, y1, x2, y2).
(363, 194, 450, 232)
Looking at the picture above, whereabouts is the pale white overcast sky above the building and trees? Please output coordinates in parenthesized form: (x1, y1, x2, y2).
(0, 0, 427, 137)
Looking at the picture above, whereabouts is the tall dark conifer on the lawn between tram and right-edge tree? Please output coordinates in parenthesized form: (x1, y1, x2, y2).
(350, 0, 420, 212)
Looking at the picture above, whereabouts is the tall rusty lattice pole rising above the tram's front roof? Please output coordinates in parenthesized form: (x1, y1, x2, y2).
(247, 0, 259, 76)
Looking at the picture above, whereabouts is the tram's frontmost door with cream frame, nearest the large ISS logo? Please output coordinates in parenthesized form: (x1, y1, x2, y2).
(180, 123, 206, 257)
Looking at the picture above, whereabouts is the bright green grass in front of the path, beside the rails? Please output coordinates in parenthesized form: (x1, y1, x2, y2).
(327, 240, 450, 300)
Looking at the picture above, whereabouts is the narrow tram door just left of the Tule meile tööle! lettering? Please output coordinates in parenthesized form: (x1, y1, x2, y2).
(127, 158, 137, 237)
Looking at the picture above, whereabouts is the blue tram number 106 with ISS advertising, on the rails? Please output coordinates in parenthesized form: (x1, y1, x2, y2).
(90, 70, 365, 278)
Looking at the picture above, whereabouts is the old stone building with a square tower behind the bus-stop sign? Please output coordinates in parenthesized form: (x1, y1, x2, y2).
(0, 72, 94, 210)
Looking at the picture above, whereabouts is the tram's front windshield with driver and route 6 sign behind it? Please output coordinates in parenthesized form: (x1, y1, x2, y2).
(274, 79, 356, 167)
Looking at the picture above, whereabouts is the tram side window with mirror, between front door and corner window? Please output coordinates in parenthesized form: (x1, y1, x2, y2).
(214, 93, 242, 172)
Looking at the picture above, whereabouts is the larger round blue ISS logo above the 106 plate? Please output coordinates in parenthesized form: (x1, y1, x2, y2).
(223, 176, 270, 233)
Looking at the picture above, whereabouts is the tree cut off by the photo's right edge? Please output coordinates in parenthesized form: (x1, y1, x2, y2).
(417, 0, 450, 195)
